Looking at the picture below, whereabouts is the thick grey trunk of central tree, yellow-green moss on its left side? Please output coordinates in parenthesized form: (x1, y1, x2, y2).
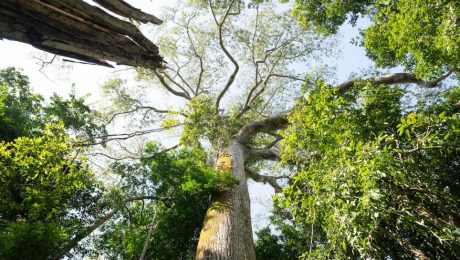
(196, 139, 256, 260)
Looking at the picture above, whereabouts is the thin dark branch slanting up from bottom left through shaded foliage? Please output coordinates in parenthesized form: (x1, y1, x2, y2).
(52, 196, 165, 259)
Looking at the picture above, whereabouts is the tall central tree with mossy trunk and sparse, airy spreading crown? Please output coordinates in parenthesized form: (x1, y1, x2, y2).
(97, 1, 331, 259)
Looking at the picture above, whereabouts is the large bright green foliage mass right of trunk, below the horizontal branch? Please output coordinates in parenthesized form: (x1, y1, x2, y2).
(276, 81, 460, 259)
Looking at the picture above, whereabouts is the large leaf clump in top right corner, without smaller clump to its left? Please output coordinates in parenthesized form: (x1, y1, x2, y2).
(364, 0, 460, 78)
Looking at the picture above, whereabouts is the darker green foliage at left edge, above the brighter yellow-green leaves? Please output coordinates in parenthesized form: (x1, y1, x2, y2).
(0, 67, 105, 141)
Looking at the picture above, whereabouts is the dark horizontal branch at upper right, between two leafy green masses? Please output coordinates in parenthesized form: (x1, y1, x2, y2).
(337, 70, 454, 92)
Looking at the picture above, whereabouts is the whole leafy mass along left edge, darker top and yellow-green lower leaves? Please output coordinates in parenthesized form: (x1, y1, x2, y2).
(0, 68, 103, 259)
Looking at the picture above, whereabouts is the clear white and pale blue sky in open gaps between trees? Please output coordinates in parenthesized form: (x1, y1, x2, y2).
(0, 0, 372, 235)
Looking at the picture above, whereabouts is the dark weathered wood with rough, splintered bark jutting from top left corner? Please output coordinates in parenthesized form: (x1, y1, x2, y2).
(0, 0, 162, 69)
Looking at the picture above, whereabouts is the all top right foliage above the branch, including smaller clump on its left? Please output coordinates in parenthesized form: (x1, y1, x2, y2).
(293, 0, 460, 79)
